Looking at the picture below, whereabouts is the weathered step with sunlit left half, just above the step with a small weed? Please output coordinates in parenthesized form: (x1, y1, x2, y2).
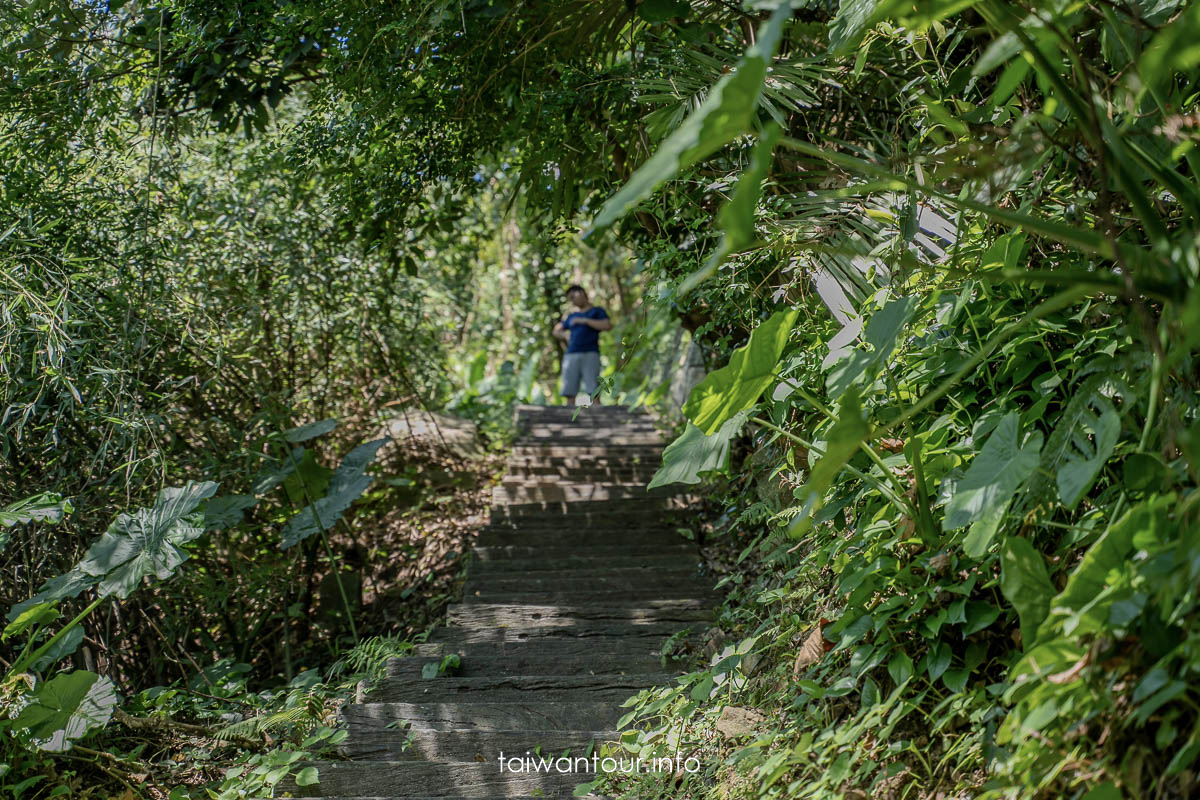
(446, 600, 713, 630)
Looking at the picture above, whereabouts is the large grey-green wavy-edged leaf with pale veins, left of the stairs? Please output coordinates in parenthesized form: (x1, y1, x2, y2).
(79, 481, 217, 597)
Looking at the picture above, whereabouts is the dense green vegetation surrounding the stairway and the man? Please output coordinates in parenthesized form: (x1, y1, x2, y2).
(0, 0, 1200, 800)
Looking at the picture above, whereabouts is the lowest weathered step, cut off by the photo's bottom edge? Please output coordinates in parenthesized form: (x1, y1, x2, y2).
(283, 760, 580, 798)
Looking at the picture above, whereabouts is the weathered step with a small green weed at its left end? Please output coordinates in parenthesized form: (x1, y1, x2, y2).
(403, 634, 686, 680)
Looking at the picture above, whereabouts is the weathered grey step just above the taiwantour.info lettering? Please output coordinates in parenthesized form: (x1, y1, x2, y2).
(342, 692, 624, 735)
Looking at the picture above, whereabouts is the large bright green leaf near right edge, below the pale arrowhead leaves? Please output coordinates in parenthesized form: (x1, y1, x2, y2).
(1039, 494, 1175, 637)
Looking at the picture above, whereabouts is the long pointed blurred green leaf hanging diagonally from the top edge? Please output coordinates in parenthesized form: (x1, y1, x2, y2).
(586, 2, 792, 236)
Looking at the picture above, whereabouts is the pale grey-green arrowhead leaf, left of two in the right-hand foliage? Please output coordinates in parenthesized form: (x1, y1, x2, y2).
(942, 411, 1042, 531)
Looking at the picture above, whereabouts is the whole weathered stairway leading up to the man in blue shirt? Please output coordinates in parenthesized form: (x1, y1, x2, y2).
(288, 405, 716, 800)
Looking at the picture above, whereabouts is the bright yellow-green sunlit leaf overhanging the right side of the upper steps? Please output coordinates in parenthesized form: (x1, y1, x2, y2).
(683, 309, 798, 435)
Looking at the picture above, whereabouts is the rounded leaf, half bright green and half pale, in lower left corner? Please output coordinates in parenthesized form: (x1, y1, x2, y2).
(12, 669, 116, 753)
